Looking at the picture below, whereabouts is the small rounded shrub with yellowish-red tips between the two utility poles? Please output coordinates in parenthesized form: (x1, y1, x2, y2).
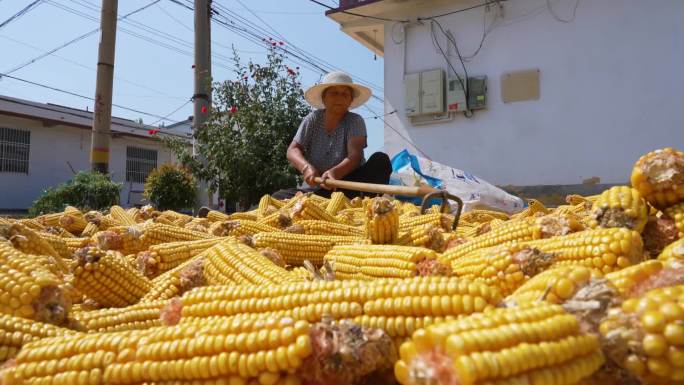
(144, 164, 195, 211)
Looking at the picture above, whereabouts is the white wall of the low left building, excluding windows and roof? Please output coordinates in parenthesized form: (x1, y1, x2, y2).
(0, 116, 175, 210)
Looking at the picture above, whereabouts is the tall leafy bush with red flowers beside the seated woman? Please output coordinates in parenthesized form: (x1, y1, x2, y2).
(166, 43, 310, 207)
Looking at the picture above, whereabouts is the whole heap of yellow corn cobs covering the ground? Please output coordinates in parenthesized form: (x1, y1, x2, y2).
(0, 149, 684, 385)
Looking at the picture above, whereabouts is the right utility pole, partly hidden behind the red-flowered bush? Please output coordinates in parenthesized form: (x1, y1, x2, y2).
(192, 0, 212, 206)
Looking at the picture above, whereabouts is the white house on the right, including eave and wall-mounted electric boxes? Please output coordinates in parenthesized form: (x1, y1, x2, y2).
(326, 0, 684, 192)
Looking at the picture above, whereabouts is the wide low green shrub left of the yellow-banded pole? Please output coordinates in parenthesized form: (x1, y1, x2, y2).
(29, 171, 121, 216)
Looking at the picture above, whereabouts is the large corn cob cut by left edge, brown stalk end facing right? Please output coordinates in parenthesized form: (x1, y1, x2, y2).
(0, 238, 69, 325)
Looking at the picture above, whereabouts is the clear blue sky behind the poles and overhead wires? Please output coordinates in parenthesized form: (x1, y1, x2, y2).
(0, 0, 383, 156)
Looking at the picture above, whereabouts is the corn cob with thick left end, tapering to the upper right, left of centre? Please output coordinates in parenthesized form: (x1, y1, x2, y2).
(136, 237, 226, 277)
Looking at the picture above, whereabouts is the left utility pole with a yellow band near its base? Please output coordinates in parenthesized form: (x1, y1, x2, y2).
(90, 0, 118, 174)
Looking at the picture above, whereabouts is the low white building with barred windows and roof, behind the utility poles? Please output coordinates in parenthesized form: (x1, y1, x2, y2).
(0, 96, 191, 211)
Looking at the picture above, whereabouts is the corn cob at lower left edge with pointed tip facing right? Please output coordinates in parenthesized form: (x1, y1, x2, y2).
(0, 313, 76, 363)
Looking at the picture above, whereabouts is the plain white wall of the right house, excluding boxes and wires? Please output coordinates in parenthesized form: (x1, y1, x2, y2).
(384, 0, 684, 185)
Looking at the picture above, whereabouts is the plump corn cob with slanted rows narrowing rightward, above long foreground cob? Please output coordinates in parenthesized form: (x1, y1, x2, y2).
(204, 240, 294, 285)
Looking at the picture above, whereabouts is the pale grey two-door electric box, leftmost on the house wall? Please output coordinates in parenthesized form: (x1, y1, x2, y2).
(404, 69, 444, 116)
